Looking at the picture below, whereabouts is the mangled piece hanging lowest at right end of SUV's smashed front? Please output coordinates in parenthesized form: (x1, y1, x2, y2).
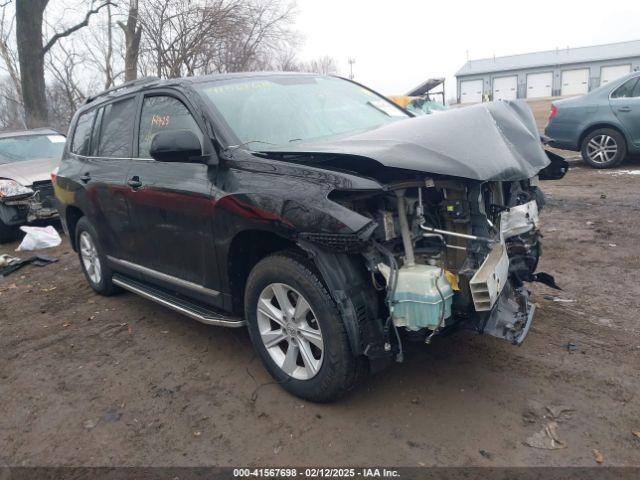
(481, 284, 535, 345)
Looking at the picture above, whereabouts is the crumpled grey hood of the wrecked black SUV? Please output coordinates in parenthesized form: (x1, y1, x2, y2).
(264, 101, 549, 181)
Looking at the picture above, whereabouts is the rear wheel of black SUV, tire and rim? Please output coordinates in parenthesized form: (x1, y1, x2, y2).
(75, 217, 118, 297)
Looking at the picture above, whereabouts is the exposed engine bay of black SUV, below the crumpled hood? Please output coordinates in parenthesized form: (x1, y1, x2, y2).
(329, 176, 553, 352)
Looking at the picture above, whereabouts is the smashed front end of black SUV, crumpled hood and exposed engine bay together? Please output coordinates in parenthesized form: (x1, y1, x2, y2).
(252, 102, 568, 364)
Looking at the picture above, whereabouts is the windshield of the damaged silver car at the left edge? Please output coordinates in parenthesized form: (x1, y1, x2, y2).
(0, 134, 66, 164)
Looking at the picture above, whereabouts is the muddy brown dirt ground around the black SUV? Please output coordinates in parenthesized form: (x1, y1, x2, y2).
(0, 103, 640, 466)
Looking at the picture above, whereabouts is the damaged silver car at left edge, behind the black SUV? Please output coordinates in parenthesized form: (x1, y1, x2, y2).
(0, 128, 66, 243)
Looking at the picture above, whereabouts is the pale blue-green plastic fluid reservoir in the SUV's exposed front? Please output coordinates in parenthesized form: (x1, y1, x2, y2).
(392, 265, 453, 330)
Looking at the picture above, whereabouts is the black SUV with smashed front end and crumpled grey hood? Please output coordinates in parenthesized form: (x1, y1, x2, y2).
(56, 73, 565, 401)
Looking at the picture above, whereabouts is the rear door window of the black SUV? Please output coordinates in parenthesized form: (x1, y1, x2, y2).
(98, 98, 136, 158)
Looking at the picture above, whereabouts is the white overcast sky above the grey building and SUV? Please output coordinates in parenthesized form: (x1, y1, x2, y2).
(297, 0, 640, 98)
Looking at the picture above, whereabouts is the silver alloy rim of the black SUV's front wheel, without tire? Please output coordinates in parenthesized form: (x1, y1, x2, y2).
(257, 283, 324, 380)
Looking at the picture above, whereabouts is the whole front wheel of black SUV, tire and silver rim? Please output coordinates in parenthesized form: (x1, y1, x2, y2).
(245, 253, 359, 402)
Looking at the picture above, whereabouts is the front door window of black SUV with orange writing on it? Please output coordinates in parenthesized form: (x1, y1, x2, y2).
(138, 96, 202, 158)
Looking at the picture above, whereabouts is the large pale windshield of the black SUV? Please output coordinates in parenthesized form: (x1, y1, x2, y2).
(199, 75, 408, 150)
